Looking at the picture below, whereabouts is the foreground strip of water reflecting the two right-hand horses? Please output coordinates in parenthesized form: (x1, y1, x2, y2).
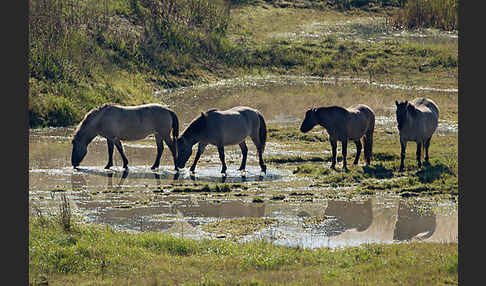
(31, 192, 458, 248)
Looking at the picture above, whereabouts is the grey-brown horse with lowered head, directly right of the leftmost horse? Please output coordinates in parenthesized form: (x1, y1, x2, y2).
(177, 106, 267, 174)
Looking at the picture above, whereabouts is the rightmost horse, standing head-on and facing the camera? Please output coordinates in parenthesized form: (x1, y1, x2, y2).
(395, 98, 439, 172)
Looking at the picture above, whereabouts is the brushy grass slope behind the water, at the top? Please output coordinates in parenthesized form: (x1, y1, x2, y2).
(28, 0, 457, 127)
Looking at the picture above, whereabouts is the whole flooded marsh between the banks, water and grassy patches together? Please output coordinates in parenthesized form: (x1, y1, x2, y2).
(29, 77, 458, 248)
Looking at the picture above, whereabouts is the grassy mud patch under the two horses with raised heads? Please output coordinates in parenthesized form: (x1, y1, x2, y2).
(267, 123, 459, 199)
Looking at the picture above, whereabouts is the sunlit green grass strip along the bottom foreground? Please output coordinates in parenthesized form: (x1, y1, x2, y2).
(29, 218, 458, 285)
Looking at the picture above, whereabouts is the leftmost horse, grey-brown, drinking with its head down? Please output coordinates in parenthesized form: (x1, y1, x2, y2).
(71, 104, 179, 171)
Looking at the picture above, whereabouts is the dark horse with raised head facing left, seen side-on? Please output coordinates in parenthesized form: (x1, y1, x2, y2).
(300, 104, 375, 172)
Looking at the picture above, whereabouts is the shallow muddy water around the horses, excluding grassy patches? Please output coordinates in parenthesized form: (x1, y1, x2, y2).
(29, 76, 457, 248)
